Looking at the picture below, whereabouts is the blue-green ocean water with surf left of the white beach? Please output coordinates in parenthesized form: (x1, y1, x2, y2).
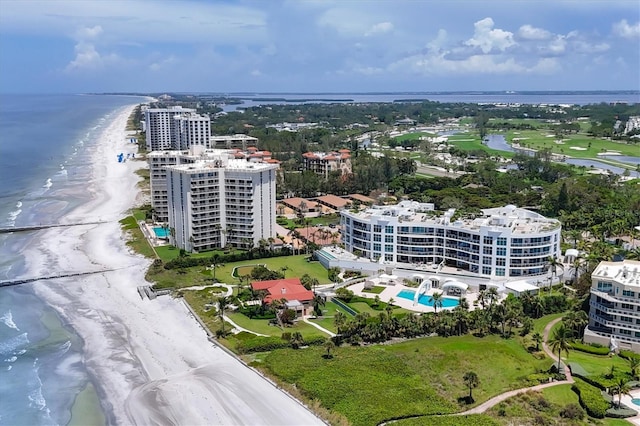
(0, 94, 145, 425)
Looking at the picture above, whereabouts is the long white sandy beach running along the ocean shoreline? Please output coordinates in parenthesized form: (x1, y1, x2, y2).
(26, 106, 322, 425)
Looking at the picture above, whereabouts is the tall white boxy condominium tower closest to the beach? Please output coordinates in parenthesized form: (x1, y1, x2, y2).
(166, 152, 278, 251)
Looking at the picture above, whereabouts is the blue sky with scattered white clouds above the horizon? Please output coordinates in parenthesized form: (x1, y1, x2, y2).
(0, 0, 640, 93)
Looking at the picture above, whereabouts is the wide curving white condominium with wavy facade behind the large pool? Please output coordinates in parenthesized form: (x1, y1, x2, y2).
(340, 201, 561, 278)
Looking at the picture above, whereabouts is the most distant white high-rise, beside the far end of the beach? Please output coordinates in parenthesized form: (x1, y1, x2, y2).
(145, 106, 211, 151)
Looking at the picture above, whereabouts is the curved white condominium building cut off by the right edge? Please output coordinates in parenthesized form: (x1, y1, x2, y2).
(584, 260, 640, 352)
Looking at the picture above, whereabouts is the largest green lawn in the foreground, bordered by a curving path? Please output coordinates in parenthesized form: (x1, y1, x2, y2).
(264, 336, 548, 425)
